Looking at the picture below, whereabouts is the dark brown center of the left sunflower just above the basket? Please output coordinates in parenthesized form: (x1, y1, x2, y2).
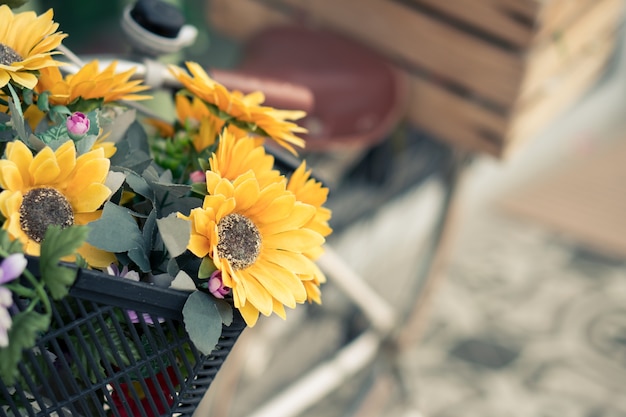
(20, 188, 74, 243)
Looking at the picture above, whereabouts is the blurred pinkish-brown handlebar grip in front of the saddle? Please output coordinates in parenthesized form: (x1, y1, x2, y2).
(209, 69, 315, 113)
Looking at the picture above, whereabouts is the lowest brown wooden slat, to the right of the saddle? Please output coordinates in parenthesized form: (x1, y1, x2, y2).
(407, 77, 506, 156)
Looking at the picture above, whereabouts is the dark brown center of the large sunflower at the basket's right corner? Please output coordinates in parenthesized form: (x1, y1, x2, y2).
(217, 213, 261, 270)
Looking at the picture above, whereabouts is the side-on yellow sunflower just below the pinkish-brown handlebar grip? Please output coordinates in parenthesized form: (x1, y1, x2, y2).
(170, 62, 306, 154)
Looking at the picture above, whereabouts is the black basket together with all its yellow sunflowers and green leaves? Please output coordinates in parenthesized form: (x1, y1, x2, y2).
(0, 5, 331, 416)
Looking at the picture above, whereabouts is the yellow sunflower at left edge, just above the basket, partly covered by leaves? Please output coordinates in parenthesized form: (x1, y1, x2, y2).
(0, 141, 115, 267)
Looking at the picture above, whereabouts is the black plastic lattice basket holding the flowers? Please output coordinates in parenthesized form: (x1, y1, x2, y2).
(0, 264, 245, 417)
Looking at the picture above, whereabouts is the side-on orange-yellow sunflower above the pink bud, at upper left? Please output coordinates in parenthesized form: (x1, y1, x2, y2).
(36, 60, 150, 106)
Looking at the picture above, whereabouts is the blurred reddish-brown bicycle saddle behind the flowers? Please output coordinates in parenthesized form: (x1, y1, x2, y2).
(238, 26, 408, 151)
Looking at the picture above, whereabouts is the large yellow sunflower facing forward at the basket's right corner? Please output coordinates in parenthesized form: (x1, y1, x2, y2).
(180, 166, 324, 326)
